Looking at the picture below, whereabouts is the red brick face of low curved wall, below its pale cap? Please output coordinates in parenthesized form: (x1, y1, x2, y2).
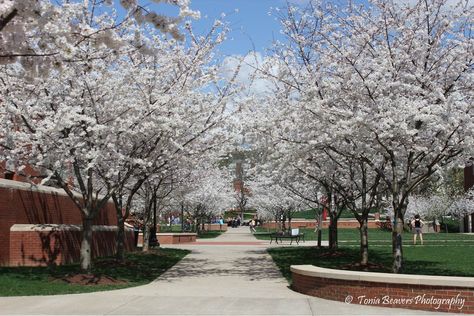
(292, 272, 474, 314)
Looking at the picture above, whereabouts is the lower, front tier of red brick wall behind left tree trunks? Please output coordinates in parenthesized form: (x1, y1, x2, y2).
(9, 230, 135, 266)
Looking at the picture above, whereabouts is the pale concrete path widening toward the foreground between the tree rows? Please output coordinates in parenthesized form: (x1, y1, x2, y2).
(0, 227, 450, 315)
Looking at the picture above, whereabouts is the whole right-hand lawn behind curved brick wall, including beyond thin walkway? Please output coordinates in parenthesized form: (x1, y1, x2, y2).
(264, 229, 474, 279)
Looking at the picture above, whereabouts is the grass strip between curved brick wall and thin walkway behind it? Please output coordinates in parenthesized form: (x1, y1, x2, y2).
(268, 245, 474, 282)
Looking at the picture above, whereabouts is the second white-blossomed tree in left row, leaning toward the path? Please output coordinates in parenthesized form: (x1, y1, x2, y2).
(95, 22, 232, 258)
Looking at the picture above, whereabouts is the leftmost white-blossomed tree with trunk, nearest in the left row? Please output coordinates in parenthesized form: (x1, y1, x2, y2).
(1, 10, 144, 270)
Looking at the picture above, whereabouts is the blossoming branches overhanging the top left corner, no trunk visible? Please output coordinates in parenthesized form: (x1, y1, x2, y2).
(0, 0, 199, 68)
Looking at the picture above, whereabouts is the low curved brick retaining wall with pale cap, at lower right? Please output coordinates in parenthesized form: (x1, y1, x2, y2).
(291, 266, 474, 314)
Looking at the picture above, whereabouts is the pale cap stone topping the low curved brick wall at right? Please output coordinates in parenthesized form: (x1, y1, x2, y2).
(290, 265, 474, 288)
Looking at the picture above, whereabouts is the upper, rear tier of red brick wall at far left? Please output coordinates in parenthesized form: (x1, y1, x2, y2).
(0, 179, 117, 265)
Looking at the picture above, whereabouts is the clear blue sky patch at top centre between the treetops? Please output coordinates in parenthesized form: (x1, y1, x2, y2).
(135, 0, 307, 56)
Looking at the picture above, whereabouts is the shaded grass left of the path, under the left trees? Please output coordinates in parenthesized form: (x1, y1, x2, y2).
(0, 248, 189, 296)
